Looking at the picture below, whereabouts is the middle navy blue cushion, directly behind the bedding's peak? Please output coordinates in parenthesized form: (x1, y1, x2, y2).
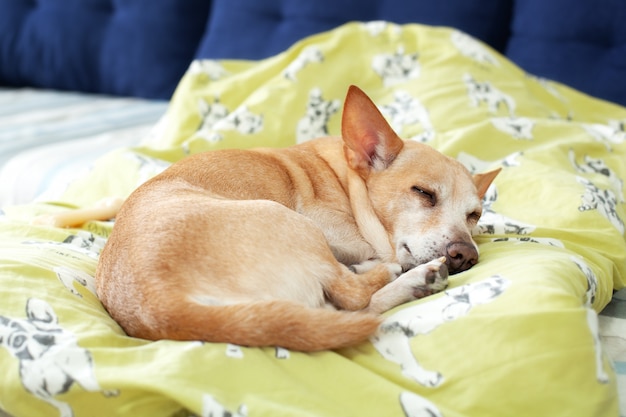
(197, 0, 512, 59)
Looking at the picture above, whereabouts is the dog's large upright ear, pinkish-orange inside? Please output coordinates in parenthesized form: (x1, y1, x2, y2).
(341, 85, 404, 176)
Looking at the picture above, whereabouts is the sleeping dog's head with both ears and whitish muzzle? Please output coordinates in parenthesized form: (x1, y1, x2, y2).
(342, 86, 500, 273)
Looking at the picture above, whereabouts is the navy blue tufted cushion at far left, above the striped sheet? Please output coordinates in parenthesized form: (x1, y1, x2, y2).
(0, 0, 210, 98)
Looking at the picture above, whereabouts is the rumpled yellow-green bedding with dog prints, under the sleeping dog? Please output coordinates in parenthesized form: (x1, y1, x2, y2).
(0, 22, 626, 417)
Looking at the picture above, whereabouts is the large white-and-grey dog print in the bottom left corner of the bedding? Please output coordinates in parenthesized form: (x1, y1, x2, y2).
(0, 298, 117, 417)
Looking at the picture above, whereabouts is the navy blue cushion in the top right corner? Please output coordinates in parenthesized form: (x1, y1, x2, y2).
(506, 0, 626, 105)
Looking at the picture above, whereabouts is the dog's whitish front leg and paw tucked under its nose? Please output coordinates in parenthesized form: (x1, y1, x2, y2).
(367, 257, 448, 314)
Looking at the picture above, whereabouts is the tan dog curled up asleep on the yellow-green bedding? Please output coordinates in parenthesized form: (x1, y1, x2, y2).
(96, 87, 499, 351)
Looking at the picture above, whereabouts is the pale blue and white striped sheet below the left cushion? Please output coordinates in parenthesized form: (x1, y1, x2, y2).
(0, 88, 168, 207)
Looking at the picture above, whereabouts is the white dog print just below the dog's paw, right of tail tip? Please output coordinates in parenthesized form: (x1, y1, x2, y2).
(371, 275, 509, 387)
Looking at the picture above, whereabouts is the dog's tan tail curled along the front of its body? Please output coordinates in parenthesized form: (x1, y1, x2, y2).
(136, 300, 382, 352)
